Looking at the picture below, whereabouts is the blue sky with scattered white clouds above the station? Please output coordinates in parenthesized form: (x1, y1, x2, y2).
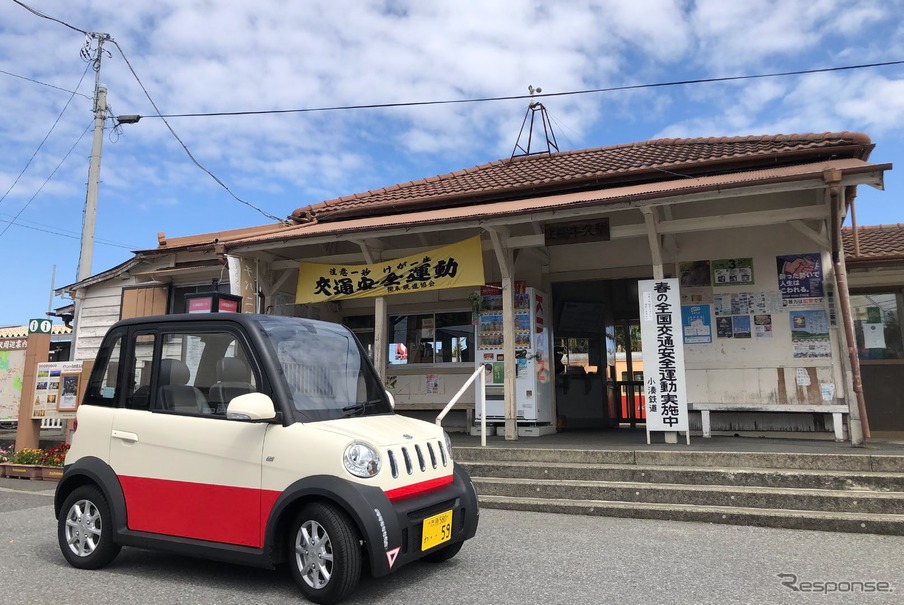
(0, 0, 904, 326)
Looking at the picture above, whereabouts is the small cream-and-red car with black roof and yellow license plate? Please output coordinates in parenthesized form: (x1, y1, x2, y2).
(54, 313, 479, 603)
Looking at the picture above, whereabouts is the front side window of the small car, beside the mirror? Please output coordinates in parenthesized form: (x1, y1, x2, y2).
(152, 332, 259, 417)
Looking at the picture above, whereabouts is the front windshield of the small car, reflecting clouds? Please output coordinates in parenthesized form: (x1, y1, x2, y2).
(259, 316, 392, 422)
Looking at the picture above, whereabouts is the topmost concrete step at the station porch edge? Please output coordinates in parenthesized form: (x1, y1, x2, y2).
(454, 446, 904, 473)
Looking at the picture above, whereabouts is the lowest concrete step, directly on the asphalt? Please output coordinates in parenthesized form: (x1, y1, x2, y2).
(480, 495, 904, 536)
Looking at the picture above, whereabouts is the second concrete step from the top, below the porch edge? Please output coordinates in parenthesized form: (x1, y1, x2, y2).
(456, 462, 904, 492)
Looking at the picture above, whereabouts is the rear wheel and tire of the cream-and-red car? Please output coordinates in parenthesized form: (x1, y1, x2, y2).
(57, 485, 122, 569)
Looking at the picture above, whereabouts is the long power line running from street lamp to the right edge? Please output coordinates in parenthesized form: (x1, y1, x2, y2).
(129, 60, 904, 121)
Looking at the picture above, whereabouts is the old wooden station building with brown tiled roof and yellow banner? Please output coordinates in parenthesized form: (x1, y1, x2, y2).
(59, 132, 904, 445)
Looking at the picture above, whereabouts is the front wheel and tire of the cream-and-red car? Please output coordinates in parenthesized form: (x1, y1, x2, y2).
(288, 502, 362, 605)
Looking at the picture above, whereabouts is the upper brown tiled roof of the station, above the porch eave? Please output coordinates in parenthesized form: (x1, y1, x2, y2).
(290, 132, 873, 222)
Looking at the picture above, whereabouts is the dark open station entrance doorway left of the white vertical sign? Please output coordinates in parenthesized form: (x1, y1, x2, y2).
(552, 279, 645, 431)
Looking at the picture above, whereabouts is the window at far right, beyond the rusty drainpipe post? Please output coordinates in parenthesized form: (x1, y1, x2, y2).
(851, 293, 904, 360)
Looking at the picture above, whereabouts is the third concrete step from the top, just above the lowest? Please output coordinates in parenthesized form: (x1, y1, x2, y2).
(472, 476, 904, 518)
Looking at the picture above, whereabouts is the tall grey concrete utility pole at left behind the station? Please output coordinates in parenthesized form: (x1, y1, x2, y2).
(69, 32, 111, 361)
